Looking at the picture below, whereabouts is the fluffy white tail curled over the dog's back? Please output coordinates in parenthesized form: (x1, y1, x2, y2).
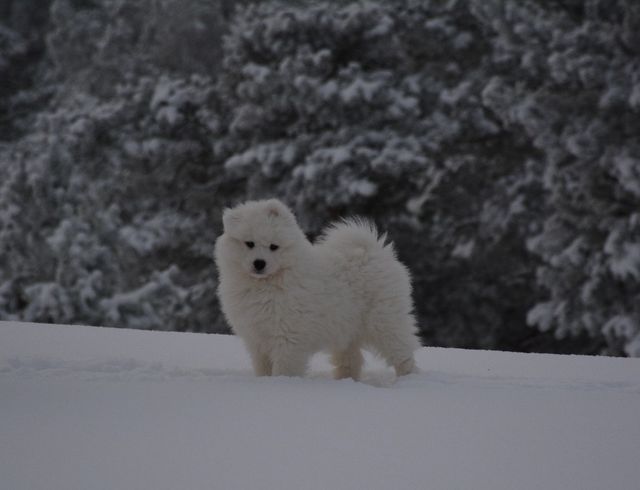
(316, 217, 396, 258)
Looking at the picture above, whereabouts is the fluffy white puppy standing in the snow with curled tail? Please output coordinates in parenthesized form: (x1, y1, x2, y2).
(215, 199, 420, 379)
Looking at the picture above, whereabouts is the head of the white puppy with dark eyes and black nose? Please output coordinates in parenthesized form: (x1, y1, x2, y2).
(216, 199, 306, 279)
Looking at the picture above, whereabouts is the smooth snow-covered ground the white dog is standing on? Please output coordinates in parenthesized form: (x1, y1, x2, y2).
(0, 322, 640, 490)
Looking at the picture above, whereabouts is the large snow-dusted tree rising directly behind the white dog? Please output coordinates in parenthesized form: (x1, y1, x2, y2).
(216, 1, 552, 347)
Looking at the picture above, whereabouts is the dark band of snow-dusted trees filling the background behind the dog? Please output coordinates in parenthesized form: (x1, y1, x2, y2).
(0, 0, 640, 356)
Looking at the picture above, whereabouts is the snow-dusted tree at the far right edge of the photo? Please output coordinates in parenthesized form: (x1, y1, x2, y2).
(482, 1, 640, 356)
